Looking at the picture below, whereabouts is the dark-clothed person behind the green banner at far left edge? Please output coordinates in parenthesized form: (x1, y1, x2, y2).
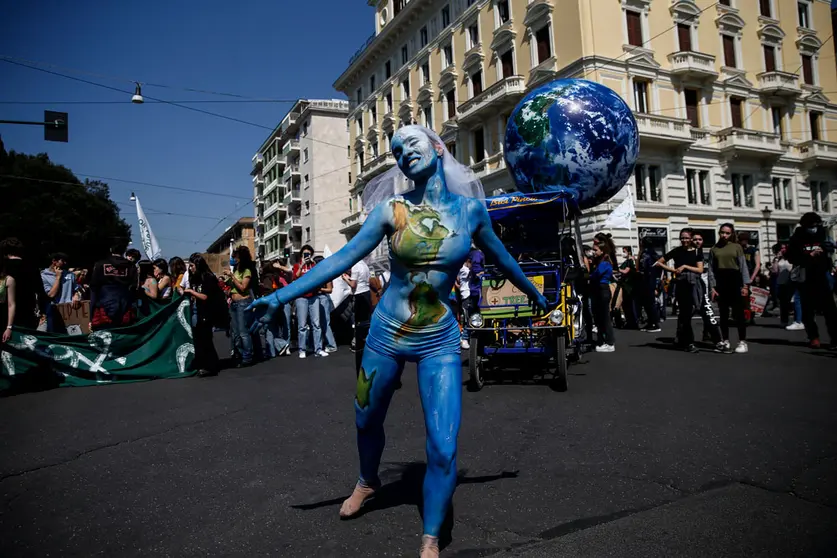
(0, 237, 50, 329)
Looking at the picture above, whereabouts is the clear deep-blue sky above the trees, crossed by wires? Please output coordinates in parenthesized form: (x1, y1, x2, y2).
(0, 0, 374, 257)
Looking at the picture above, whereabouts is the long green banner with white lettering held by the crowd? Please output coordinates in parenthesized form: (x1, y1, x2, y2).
(0, 299, 195, 391)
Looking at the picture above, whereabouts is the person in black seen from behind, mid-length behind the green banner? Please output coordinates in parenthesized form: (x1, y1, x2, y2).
(90, 241, 137, 331)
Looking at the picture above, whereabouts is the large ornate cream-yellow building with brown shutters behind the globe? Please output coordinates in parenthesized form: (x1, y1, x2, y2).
(335, 0, 837, 256)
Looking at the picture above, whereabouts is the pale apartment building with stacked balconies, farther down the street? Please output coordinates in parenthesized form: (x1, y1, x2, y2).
(251, 99, 350, 261)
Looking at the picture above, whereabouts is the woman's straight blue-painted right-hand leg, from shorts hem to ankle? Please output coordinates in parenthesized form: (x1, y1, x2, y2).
(418, 354, 462, 537)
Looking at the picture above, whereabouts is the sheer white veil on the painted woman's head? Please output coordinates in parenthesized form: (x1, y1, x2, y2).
(362, 125, 485, 214)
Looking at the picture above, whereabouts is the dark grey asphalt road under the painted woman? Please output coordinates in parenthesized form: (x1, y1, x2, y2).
(0, 320, 837, 558)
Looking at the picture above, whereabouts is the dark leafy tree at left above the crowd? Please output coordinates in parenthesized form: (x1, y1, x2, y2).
(0, 141, 131, 268)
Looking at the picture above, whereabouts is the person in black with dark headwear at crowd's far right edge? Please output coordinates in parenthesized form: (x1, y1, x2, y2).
(787, 212, 837, 349)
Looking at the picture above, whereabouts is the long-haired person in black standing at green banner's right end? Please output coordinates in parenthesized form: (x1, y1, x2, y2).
(181, 252, 229, 377)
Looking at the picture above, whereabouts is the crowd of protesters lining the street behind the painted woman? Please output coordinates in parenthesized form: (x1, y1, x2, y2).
(0, 213, 837, 388)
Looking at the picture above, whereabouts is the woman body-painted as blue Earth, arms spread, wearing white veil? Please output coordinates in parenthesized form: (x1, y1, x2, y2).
(250, 126, 547, 558)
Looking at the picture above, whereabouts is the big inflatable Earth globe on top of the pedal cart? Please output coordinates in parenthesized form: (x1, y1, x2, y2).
(505, 79, 639, 209)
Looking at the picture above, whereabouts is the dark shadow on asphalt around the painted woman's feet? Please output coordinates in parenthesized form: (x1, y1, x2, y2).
(291, 462, 518, 548)
